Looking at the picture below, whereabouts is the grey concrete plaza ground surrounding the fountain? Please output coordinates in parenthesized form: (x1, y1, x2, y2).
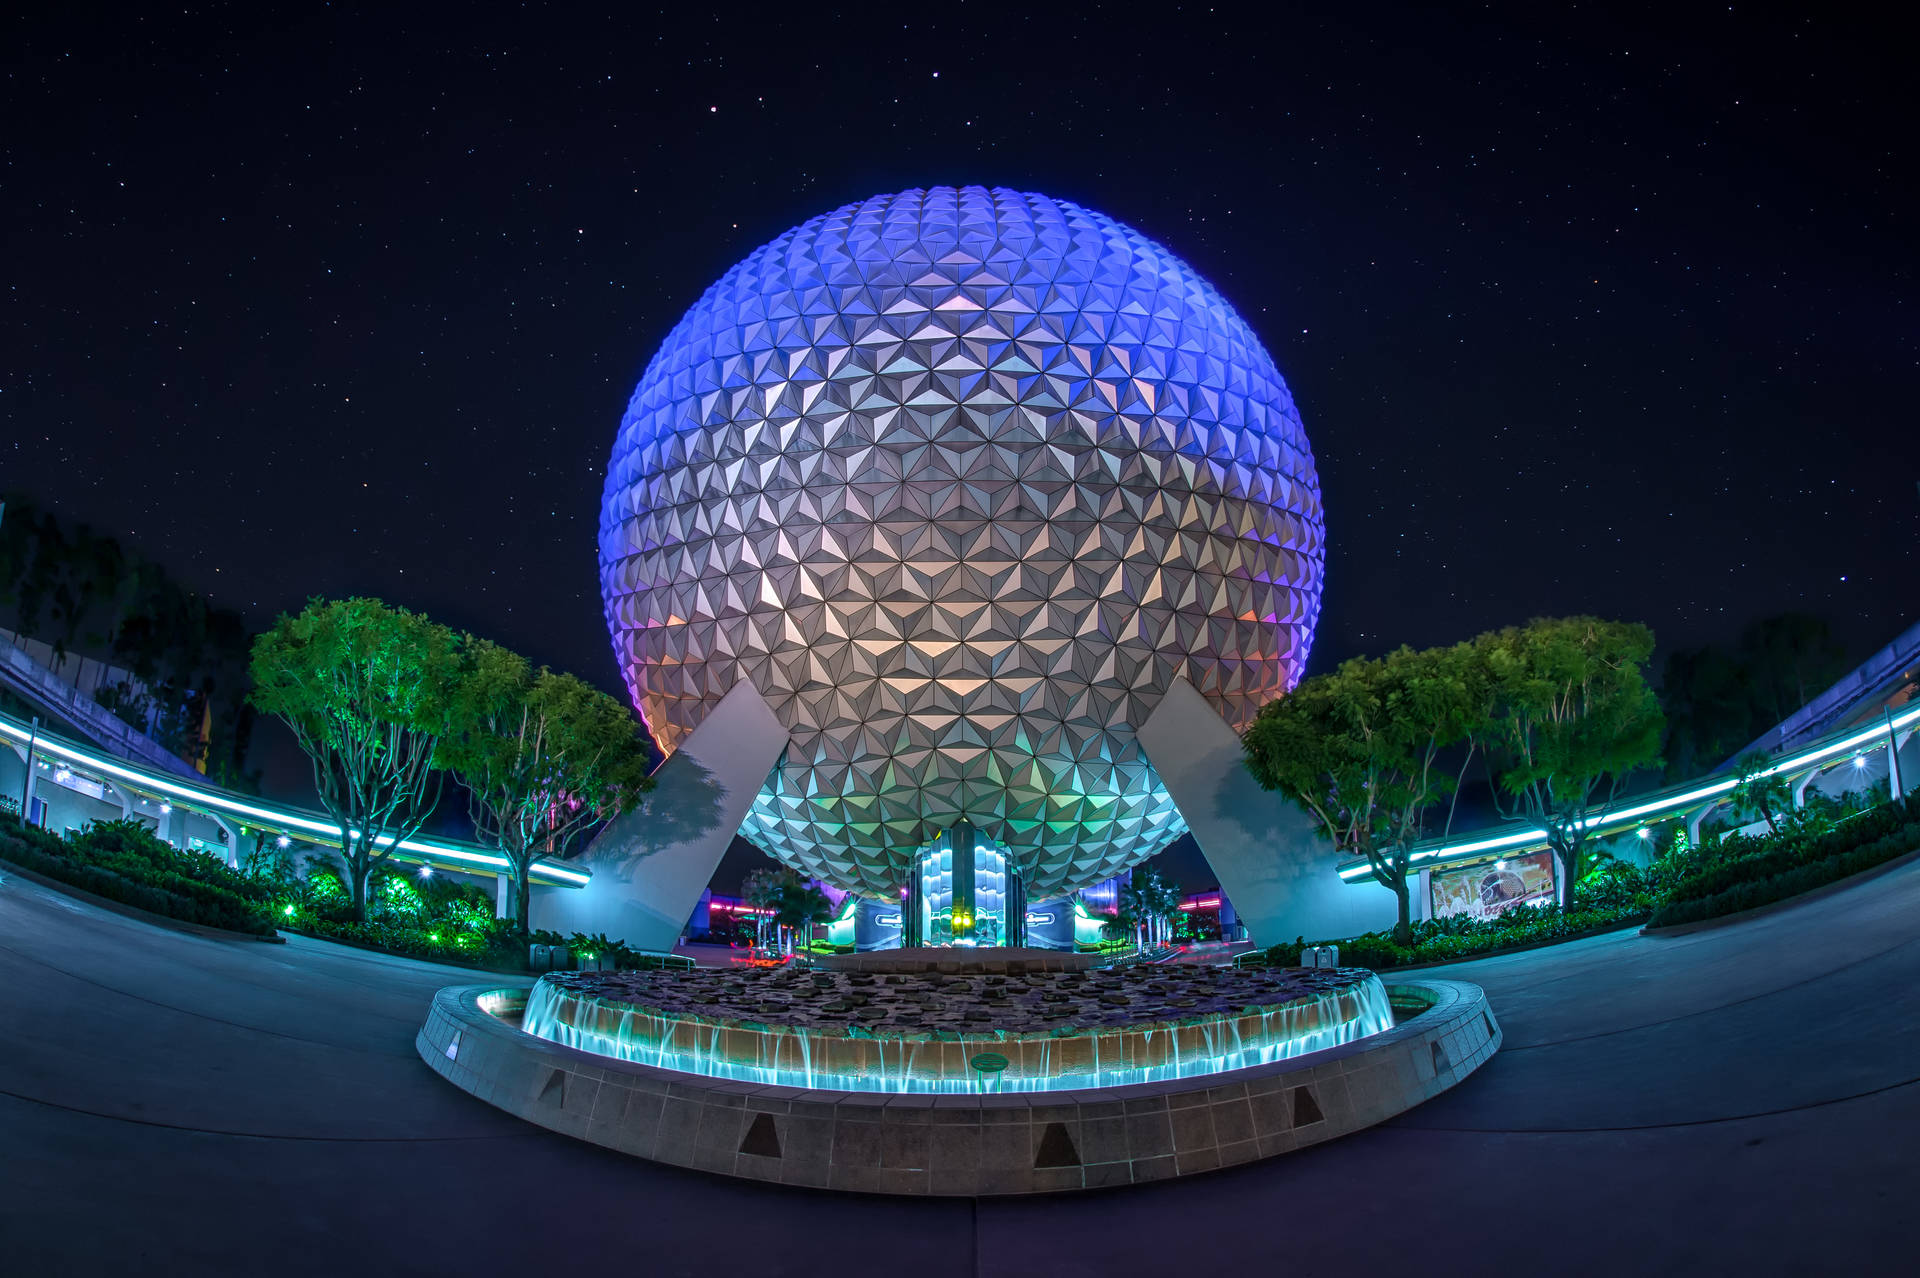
(0, 865, 1920, 1278)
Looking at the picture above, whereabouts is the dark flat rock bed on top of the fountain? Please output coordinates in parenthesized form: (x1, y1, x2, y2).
(541, 965, 1373, 1038)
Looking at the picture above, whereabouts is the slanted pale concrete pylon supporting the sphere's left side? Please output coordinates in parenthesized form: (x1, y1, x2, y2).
(528, 683, 787, 950)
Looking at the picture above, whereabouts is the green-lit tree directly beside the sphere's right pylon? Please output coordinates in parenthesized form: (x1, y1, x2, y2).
(1244, 643, 1490, 944)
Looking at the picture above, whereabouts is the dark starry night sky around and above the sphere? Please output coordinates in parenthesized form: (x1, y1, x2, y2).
(0, 4, 1920, 821)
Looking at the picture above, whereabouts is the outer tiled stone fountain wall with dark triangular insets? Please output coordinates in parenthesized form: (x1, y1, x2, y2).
(415, 977, 1500, 1195)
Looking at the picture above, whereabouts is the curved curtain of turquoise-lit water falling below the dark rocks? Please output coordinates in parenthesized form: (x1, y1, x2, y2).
(522, 969, 1394, 1094)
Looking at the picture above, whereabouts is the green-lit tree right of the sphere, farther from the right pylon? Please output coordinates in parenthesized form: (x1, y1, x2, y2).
(1475, 616, 1667, 908)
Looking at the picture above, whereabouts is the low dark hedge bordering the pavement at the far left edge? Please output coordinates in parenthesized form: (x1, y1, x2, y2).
(0, 814, 275, 936)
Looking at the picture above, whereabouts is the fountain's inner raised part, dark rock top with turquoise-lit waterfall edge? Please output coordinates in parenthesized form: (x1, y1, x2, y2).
(522, 952, 1394, 1094)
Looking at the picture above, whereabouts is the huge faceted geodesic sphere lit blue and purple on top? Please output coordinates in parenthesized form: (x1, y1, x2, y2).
(599, 186, 1325, 900)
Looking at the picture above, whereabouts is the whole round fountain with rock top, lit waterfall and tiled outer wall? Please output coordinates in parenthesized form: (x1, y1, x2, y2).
(415, 952, 1500, 1195)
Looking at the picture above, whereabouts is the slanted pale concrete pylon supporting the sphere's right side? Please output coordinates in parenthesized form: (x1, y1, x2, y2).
(1135, 679, 1396, 946)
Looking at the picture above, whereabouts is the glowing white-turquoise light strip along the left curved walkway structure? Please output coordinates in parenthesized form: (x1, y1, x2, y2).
(0, 714, 593, 887)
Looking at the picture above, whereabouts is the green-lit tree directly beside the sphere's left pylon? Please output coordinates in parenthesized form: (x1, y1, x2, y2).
(440, 637, 653, 933)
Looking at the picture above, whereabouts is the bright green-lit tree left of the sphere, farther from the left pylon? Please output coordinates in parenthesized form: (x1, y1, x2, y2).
(252, 599, 463, 921)
